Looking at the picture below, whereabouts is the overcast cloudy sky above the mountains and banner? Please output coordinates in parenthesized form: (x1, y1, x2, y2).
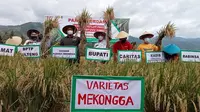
(0, 0, 200, 38)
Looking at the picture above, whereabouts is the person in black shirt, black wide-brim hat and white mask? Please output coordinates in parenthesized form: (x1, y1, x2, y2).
(60, 25, 81, 63)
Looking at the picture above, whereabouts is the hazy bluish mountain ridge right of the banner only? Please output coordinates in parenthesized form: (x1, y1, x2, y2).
(128, 36, 200, 50)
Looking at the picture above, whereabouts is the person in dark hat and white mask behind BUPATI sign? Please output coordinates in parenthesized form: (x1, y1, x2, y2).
(94, 31, 106, 48)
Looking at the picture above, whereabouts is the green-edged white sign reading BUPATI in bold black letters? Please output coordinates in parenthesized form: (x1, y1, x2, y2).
(86, 48, 111, 61)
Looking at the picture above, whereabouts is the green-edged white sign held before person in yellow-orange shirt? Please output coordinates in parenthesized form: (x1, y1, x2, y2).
(145, 52, 165, 63)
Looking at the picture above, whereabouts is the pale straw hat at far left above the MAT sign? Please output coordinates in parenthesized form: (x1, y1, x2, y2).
(6, 36, 22, 45)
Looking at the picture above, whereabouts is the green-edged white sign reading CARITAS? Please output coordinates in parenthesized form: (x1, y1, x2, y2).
(118, 50, 142, 62)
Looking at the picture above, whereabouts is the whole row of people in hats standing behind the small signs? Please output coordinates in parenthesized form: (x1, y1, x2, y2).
(2, 25, 180, 63)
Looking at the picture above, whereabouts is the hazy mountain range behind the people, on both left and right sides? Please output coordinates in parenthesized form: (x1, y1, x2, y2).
(0, 22, 200, 50)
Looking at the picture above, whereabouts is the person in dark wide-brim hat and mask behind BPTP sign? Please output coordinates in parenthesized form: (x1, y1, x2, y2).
(24, 29, 42, 45)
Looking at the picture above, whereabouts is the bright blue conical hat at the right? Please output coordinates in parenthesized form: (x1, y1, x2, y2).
(163, 44, 181, 55)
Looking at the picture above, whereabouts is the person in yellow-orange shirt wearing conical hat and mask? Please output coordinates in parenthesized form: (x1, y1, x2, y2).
(137, 31, 161, 61)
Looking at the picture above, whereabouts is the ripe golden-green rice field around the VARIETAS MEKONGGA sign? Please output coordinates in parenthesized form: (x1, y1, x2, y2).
(0, 55, 200, 112)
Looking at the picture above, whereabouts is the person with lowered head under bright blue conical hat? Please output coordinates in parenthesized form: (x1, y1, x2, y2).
(163, 44, 181, 62)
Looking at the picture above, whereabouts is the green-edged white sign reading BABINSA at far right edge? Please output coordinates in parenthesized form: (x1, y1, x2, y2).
(181, 50, 200, 62)
